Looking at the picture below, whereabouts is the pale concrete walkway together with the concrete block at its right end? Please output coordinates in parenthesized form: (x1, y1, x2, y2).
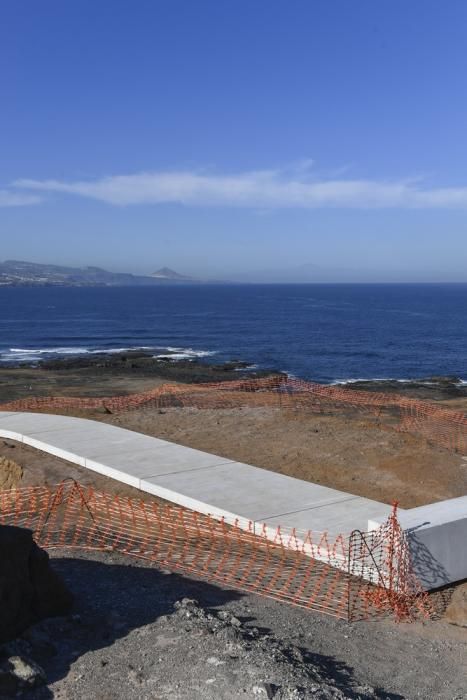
(0, 411, 467, 589)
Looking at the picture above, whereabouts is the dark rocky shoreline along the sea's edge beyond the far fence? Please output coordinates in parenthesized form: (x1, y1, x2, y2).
(0, 350, 467, 401)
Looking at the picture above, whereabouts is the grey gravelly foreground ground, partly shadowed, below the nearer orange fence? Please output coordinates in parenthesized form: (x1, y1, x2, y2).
(7, 551, 467, 700)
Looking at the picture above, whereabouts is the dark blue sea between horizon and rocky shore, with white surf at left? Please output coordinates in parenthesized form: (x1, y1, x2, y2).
(0, 284, 467, 383)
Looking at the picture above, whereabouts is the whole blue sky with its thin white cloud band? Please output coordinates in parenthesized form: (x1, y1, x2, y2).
(0, 0, 467, 281)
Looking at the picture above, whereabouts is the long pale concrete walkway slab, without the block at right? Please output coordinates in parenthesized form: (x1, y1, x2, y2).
(0, 412, 391, 535)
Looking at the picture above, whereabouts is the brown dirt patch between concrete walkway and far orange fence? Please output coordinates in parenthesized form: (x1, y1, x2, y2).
(100, 408, 467, 508)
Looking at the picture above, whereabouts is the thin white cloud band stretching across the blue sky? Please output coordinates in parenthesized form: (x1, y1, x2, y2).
(13, 169, 467, 209)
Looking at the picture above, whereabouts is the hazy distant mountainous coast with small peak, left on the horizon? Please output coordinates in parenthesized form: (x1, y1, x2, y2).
(0, 260, 205, 287)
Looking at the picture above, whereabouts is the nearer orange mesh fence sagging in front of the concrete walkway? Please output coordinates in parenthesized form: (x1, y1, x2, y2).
(0, 480, 430, 620)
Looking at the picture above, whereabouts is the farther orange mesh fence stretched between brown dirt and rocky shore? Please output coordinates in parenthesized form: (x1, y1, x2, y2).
(0, 376, 467, 454)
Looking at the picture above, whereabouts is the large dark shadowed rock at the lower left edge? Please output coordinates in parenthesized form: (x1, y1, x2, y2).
(0, 526, 73, 642)
